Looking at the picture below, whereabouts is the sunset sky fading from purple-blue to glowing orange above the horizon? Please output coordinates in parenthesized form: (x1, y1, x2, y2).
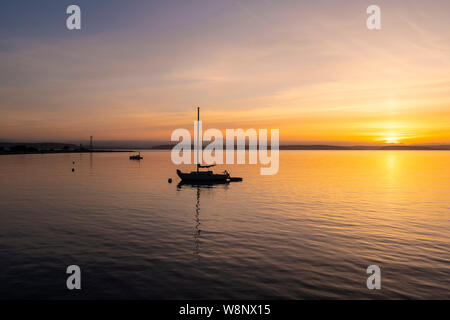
(0, 0, 450, 144)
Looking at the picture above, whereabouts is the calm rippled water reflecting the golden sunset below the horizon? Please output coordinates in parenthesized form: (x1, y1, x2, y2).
(0, 151, 450, 299)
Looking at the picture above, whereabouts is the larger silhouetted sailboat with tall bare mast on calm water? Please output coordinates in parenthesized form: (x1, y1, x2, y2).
(177, 108, 242, 184)
